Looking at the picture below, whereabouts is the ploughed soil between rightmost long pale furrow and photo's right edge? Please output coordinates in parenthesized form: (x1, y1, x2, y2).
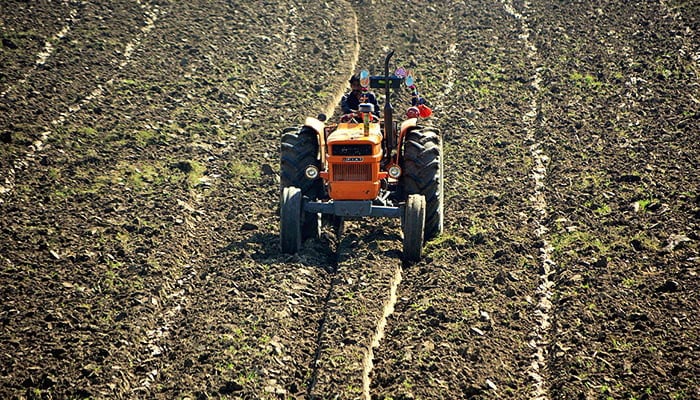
(528, 1, 700, 398)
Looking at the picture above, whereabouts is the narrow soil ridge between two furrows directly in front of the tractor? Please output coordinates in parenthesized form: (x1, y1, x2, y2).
(308, 225, 401, 398)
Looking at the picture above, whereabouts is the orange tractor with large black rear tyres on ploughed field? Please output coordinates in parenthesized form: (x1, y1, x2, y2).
(280, 51, 444, 262)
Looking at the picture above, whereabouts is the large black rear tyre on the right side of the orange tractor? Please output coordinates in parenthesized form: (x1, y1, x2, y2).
(401, 128, 444, 240)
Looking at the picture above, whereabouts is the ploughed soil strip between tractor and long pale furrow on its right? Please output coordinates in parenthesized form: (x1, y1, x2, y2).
(372, 1, 539, 398)
